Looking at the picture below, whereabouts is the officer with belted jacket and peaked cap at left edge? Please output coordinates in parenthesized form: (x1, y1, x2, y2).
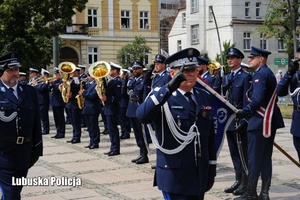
(0, 52, 43, 200)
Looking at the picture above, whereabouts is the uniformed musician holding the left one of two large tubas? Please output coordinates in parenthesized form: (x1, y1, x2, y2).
(66, 67, 81, 144)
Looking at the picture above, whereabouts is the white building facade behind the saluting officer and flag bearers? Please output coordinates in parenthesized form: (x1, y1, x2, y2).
(169, 0, 288, 72)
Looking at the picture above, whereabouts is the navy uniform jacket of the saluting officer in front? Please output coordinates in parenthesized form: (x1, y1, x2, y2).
(136, 87, 216, 196)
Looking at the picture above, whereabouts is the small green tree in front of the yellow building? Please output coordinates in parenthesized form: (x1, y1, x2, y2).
(117, 35, 152, 68)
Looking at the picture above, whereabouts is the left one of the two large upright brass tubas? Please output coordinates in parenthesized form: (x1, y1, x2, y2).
(58, 62, 76, 103)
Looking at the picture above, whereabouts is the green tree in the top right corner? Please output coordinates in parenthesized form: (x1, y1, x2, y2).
(257, 0, 299, 59)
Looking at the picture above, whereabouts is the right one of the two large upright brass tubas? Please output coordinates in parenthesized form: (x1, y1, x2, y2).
(89, 61, 110, 105)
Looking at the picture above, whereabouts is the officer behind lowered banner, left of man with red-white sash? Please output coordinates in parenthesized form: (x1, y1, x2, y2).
(222, 48, 252, 195)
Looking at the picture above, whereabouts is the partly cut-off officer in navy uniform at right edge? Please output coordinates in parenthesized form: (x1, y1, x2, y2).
(277, 47, 300, 161)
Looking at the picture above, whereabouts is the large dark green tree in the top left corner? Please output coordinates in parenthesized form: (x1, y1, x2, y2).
(0, 0, 88, 69)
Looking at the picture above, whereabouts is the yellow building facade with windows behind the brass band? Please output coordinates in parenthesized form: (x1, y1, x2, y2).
(59, 0, 160, 66)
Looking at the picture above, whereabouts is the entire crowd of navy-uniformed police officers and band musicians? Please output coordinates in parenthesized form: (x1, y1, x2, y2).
(0, 47, 300, 200)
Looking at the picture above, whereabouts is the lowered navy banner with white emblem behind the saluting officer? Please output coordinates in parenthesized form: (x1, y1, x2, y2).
(196, 76, 237, 156)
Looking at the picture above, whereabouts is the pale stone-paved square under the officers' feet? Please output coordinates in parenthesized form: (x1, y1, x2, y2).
(4, 111, 300, 200)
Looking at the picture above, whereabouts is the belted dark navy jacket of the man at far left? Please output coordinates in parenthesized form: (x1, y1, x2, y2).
(0, 81, 43, 169)
